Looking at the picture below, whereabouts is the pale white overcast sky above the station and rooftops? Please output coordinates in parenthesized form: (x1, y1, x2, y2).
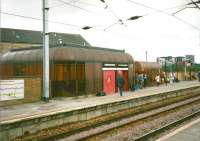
(1, 0, 200, 63)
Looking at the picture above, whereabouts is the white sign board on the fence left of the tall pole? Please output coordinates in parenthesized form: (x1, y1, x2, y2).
(0, 80, 24, 101)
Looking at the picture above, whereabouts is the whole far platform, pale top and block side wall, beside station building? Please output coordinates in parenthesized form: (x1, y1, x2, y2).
(0, 81, 200, 140)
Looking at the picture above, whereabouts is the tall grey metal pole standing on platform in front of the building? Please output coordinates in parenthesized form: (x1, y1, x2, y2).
(42, 0, 49, 101)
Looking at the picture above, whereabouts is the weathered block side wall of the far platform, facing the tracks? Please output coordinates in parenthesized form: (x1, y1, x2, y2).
(0, 87, 200, 141)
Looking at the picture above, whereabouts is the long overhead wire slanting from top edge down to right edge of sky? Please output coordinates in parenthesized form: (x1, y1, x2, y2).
(127, 0, 200, 31)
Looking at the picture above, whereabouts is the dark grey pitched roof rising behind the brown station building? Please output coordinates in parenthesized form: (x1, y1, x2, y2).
(1, 28, 91, 46)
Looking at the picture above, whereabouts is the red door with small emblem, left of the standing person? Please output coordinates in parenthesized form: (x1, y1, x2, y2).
(103, 70, 115, 95)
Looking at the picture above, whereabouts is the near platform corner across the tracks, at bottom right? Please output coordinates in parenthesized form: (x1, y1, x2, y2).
(156, 118, 200, 141)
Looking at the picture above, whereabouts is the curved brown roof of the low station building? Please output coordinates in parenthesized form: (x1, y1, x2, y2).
(1, 46, 133, 63)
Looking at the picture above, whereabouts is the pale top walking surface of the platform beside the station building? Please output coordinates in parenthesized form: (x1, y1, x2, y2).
(0, 81, 200, 123)
